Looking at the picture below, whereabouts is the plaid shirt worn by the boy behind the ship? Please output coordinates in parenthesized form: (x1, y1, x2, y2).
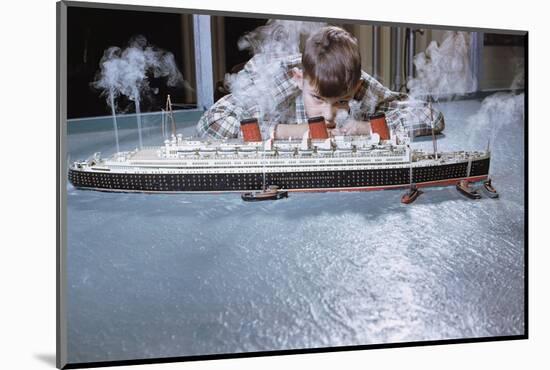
(197, 54, 445, 138)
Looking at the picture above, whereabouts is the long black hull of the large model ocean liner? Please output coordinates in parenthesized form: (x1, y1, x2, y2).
(69, 158, 489, 193)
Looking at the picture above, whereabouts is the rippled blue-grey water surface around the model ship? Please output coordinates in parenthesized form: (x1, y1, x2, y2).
(67, 101, 525, 362)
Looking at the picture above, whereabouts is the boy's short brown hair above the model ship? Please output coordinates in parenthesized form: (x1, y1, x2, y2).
(302, 26, 361, 98)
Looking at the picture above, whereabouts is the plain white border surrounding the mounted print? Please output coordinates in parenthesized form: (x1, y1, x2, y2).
(0, 0, 550, 370)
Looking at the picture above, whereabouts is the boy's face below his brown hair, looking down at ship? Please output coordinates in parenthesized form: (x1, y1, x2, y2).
(298, 72, 358, 128)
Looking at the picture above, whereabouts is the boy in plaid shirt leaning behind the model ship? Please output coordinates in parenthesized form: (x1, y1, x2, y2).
(197, 26, 445, 138)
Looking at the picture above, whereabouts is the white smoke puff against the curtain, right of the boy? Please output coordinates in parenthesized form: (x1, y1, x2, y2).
(407, 32, 475, 100)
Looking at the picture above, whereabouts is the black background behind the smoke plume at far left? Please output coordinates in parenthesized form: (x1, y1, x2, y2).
(67, 7, 187, 118)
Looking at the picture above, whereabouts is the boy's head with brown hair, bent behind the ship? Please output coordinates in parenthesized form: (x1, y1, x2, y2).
(294, 27, 361, 124)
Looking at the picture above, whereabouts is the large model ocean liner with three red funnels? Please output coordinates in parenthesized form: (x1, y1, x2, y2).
(69, 115, 496, 203)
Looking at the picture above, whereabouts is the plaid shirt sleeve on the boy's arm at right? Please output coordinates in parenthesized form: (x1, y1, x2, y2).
(354, 72, 445, 136)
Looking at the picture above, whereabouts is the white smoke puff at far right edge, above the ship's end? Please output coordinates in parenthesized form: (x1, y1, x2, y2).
(467, 93, 525, 147)
